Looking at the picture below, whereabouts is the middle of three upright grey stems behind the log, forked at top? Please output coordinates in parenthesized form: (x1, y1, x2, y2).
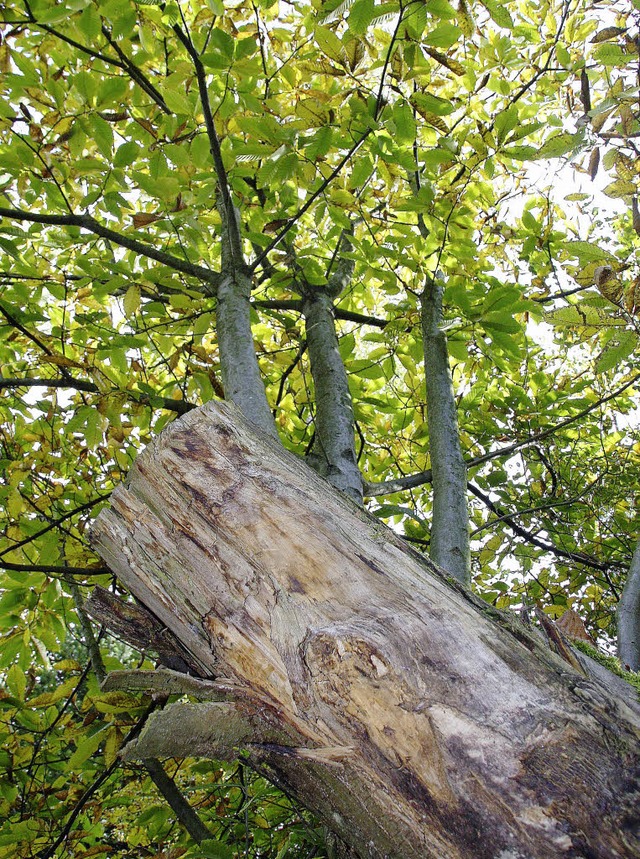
(299, 235, 362, 504)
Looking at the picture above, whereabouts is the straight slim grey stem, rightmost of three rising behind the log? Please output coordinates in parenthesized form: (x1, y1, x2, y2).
(421, 276, 471, 585)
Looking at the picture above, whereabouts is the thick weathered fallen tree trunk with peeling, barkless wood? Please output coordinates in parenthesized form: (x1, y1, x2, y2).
(92, 404, 640, 859)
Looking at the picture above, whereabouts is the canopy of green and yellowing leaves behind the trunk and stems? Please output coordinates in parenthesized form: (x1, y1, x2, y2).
(0, 0, 640, 857)
